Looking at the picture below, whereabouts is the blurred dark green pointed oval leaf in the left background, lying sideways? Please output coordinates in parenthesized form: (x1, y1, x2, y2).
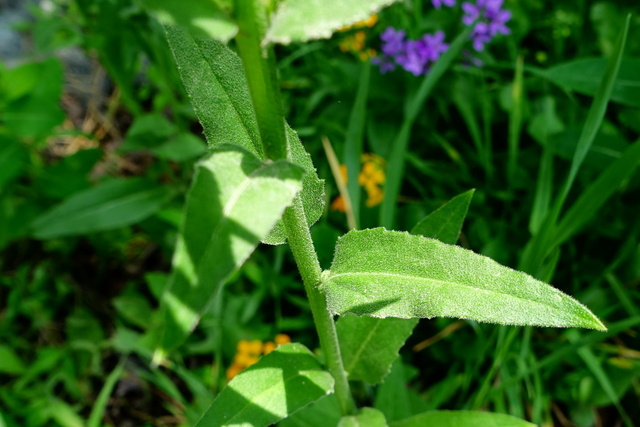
(32, 178, 172, 239)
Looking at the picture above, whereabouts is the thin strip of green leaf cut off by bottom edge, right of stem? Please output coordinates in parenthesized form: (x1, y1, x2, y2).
(390, 411, 535, 427)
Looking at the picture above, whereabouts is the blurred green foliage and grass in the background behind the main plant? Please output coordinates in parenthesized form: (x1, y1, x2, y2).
(0, 0, 640, 426)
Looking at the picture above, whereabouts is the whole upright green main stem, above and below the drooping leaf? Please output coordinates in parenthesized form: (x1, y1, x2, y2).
(235, 0, 355, 415)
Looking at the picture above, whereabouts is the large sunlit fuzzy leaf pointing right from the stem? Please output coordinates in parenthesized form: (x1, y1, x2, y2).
(321, 228, 606, 330)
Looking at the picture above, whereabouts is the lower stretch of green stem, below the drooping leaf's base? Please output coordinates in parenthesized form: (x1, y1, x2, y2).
(283, 196, 355, 415)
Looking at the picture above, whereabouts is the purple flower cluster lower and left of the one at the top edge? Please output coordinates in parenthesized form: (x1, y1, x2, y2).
(372, 27, 449, 76)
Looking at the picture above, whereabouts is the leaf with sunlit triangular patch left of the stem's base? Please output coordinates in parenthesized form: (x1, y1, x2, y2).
(196, 344, 333, 427)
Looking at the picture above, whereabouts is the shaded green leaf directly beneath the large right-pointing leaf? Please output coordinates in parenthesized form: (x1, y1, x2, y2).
(336, 316, 418, 384)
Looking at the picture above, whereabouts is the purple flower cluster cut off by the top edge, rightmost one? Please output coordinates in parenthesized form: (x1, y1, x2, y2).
(462, 0, 511, 52)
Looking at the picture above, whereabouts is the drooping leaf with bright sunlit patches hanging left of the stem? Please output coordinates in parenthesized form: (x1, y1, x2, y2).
(156, 146, 304, 357)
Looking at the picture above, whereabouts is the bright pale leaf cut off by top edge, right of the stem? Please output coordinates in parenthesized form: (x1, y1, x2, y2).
(266, 0, 395, 44)
